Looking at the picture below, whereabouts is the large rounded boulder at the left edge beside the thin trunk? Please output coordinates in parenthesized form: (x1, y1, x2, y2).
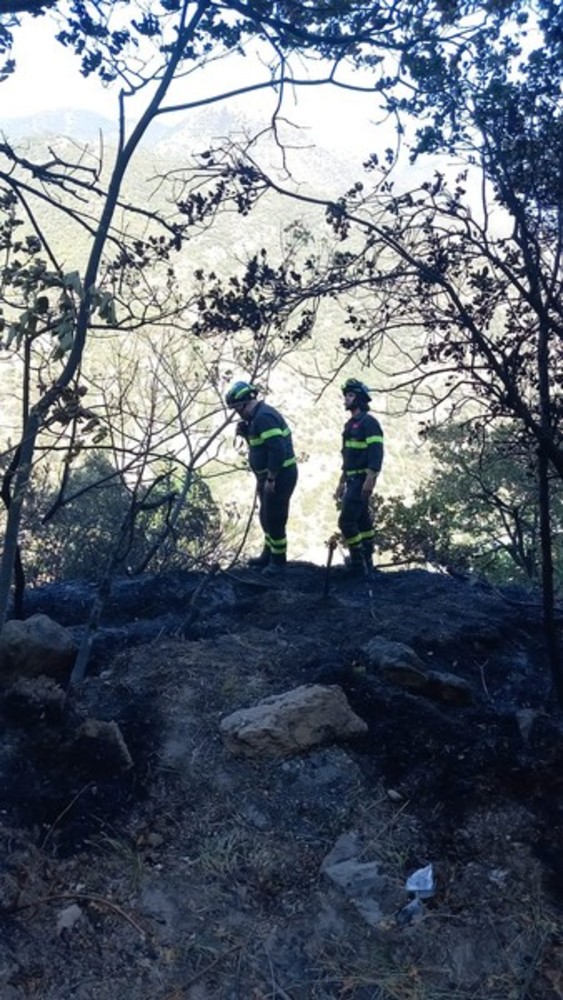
(0, 615, 76, 679)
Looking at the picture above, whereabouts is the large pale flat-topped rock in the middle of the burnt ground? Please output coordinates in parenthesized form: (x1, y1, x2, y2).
(220, 684, 368, 756)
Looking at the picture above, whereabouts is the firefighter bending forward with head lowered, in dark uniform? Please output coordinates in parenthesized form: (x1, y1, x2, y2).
(225, 382, 297, 576)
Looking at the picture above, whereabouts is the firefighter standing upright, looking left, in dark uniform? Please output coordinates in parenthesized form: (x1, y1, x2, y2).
(334, 378, 383, 574)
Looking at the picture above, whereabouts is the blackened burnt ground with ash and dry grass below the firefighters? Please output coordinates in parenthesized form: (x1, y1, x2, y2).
(0, 564, 563, 1000)
